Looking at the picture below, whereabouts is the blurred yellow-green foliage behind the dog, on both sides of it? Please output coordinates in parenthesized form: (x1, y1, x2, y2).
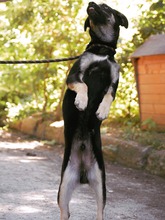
(0, 0, 165, 128)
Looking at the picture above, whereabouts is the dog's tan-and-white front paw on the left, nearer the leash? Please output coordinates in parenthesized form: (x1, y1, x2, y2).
(68, 82, 88, 111)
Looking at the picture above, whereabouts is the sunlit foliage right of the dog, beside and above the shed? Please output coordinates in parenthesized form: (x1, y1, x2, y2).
(111, 0, 165, 124)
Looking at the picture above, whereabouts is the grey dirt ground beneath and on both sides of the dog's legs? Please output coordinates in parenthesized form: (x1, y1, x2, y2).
(0, 131, 165, 220)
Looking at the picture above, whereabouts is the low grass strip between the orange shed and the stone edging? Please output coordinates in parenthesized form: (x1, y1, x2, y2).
(102, 119, 165, 150)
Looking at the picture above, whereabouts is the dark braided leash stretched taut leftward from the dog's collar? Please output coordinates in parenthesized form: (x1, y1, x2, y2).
(0, 56, 80, 64)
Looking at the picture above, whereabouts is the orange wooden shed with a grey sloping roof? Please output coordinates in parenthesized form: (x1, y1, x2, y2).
(131, 34, 165, 130)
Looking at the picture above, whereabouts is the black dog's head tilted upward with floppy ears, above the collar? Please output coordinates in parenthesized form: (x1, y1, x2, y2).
(84, 2, 128, 46)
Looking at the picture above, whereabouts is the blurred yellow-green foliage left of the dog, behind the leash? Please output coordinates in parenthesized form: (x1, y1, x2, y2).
(0, 0, 86, 123)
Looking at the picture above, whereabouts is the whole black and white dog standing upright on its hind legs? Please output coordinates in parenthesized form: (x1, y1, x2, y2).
(58, 2, 128, 220)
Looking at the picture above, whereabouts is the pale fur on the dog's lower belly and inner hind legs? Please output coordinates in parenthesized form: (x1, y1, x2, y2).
(59, 137, 104, 220)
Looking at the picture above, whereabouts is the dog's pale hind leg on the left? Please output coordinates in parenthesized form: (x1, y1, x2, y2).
(58, 162, 78, 220)
